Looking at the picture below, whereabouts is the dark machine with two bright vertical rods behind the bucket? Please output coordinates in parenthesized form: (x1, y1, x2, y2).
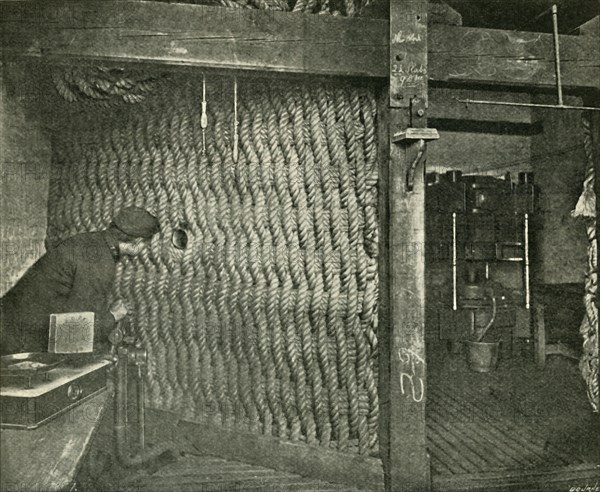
(426, 170, 536, 355)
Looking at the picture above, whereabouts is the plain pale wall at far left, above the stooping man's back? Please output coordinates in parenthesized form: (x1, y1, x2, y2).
(0, 61, 50, 296)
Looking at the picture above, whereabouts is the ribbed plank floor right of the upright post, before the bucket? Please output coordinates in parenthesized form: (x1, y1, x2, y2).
(427, 346, 600, 490)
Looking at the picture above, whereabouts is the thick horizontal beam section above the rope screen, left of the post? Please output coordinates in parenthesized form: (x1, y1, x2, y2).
(0, 0, 387, 77)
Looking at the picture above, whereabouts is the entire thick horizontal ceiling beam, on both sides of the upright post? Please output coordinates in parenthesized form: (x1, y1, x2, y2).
(0, 0, 600, 89)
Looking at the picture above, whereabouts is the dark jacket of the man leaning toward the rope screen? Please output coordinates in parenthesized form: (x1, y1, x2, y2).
(0, 231, 118, 354)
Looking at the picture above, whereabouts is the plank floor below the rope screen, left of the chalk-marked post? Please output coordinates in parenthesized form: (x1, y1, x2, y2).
(77, 408, 360, 492)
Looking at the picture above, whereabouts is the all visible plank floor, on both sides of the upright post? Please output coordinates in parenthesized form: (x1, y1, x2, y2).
(81, 351, 600, 492)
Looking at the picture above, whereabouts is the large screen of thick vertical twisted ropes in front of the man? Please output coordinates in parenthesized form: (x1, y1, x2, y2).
(48, 76, 378, 454)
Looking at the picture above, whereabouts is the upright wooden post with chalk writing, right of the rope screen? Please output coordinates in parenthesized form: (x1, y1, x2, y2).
(382, 0, 431, 492)
